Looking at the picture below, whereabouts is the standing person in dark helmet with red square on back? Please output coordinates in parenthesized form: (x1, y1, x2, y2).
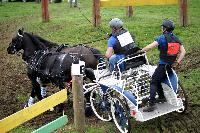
(141, 20, 186, 112)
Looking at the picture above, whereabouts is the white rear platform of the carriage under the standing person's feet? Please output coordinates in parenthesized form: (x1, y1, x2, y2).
(134, 102, 183, 122)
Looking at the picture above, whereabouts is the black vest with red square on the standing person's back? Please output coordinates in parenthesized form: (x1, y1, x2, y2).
(158, 34, 181, 64)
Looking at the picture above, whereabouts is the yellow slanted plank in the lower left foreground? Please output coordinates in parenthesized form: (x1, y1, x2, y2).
(0, 89, 67, 133)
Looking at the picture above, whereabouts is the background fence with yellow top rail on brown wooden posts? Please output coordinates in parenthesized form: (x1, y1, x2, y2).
(93, 0, 187, 27)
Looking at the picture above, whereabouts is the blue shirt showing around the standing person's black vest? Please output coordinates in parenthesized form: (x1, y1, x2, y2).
(155, 32, 173, 64)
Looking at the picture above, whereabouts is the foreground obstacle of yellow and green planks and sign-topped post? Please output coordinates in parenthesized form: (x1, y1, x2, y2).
(0, 61, 85, 133)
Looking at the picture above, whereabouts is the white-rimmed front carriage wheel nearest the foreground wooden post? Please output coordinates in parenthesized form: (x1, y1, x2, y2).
(90, 87, 112, 121)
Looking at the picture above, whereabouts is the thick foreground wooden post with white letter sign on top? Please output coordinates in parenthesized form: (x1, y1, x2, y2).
(72, 61, 85, 133)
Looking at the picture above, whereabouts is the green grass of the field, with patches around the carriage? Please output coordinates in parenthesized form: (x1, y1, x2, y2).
(0, 0, 200, 133)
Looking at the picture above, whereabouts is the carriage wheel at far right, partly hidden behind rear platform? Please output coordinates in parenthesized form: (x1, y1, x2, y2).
(177, 81, 188, 114)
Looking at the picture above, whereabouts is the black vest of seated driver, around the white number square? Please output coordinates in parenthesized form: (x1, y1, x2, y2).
(112, 29, 135, 54)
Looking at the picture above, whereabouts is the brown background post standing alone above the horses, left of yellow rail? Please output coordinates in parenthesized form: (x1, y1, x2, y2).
(42, 0, 49, 22)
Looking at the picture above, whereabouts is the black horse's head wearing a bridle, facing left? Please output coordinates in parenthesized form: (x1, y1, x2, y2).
(7, 29, 24, 54)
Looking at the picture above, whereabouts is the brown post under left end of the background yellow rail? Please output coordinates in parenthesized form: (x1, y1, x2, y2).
(93, 0, 101, 27)
